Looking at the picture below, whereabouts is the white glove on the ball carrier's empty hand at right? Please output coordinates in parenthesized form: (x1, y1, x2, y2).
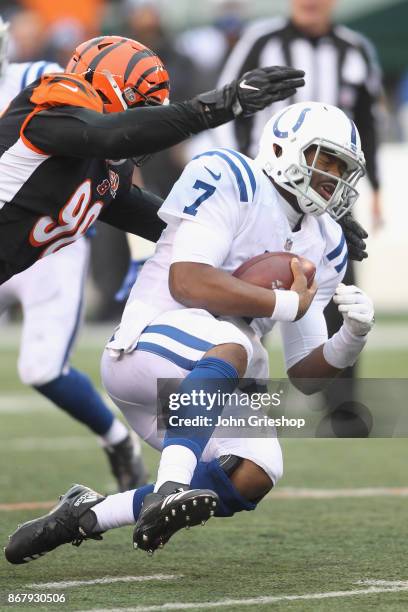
(333, 283, 374, 336)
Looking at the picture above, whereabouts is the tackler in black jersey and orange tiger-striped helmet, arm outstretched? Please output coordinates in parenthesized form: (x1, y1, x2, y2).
(0, 36, 304, 284)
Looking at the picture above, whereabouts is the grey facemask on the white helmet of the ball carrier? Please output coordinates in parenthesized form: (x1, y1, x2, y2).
(280, 138, 365, 220)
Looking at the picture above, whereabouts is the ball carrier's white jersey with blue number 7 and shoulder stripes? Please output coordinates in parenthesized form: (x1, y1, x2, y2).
(111, 149, 347, 367)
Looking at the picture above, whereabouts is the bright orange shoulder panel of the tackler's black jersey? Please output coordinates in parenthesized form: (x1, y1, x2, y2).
(30, 73, 103, 113)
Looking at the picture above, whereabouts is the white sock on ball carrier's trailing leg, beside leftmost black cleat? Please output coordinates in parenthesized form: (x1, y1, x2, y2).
(91, 489, 135, 532)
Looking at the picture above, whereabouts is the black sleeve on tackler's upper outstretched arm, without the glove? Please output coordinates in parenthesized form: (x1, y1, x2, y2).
(25, 102, 208, 159)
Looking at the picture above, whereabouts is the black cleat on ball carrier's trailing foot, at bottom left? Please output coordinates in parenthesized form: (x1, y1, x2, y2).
(4, 484, 105, 564)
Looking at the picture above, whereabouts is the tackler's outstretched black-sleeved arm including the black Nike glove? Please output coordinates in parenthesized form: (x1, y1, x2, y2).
(25, 67, 304, 159)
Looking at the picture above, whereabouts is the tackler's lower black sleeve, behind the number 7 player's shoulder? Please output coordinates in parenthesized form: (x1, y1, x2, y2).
(99, 185, 165, 242)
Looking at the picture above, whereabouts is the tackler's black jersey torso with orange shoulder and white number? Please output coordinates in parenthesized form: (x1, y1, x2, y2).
(0, 75, 133, 280)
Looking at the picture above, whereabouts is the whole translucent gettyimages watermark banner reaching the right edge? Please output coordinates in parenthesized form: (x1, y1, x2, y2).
(158, 375, 408, 438)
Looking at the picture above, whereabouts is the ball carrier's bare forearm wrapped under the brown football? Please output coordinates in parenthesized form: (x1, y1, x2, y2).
(169, 262, 275, 317)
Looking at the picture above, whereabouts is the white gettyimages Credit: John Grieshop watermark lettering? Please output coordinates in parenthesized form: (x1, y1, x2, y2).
(167, 389, 306, 429)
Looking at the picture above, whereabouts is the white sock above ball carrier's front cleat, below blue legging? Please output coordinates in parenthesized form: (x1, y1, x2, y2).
(154, 444, 197, 492)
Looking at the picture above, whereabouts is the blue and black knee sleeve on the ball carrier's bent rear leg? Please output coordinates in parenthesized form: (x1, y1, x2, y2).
(191, 455, 257, 516)
